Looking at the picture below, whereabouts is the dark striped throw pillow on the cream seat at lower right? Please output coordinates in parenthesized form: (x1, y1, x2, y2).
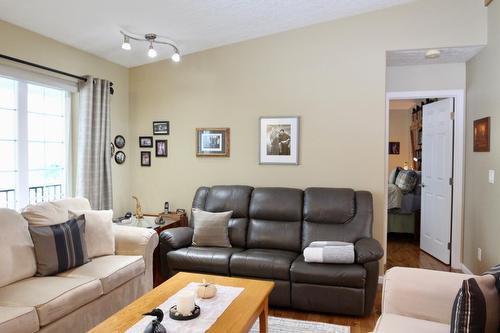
(451, 274, 500, 333)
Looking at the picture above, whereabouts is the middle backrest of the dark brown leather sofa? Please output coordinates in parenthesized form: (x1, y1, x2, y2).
(247, 187, 303, 252)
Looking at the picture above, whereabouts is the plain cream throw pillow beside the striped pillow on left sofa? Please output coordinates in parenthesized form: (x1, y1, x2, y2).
(69, 210, 115, 258)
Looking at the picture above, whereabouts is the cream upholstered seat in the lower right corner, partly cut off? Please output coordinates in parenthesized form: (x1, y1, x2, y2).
(374, 267, 473, 333)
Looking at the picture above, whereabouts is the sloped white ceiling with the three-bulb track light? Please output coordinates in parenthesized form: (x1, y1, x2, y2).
(0, 0, 414, 67)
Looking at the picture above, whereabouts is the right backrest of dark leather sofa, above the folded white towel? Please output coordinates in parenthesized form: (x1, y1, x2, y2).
(302, 187, 373, 249)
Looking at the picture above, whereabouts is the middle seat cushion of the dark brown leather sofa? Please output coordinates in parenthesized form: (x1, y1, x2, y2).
(230, 249, 298, 281)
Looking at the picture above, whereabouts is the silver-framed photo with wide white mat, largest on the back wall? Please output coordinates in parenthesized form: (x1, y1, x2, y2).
(259, 117, 299, 164)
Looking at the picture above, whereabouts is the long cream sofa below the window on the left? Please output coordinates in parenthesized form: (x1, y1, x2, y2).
(0, 198, 158, 333)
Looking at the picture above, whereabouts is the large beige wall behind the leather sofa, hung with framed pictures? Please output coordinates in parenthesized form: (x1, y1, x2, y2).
(129, 0, 486, 268)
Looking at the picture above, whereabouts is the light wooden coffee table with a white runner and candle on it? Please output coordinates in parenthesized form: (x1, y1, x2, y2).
(86, 272, 274, 333)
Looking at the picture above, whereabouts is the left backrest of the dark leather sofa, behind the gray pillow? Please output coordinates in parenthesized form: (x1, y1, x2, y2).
(189, 185, 253, 248)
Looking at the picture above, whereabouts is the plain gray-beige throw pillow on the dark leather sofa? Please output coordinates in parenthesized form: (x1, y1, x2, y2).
(191, 208, 233, 247)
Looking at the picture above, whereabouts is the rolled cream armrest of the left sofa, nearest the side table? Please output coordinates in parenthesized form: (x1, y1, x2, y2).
(113, 224, 158, 290)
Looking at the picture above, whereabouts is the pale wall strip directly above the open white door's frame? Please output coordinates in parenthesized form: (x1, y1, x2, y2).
(386, 63, 466, 91)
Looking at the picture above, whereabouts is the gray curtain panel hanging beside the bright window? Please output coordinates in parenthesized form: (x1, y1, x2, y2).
(76, 76, 113, 210)
